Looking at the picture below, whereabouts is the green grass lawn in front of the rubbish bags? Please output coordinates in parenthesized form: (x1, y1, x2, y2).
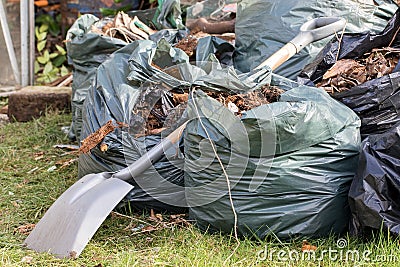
(0, 114, 400, 267)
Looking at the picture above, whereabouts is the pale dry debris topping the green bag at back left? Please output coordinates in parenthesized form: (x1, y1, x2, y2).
(91, 11, 156, 43)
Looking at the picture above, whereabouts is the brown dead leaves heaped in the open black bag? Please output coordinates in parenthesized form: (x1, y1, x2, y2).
(317, 47, 400, 93)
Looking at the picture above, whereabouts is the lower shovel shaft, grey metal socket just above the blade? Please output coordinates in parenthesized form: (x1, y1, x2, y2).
(112, 122, 187, 181)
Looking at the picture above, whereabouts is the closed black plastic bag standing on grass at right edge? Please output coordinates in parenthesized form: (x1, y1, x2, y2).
(349, 123, 400, 235)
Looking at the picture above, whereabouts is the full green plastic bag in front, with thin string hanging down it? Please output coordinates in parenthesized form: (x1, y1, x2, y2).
(184, 85, 360, 239)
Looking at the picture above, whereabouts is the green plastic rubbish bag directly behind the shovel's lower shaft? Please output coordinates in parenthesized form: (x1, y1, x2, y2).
(78, 39, 188, 212)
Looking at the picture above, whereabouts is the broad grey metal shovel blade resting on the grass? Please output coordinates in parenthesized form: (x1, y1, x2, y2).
(24, 173, 133, 258)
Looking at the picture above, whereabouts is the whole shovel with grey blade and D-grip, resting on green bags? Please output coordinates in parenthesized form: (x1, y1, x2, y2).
(24, 17, 345, 258)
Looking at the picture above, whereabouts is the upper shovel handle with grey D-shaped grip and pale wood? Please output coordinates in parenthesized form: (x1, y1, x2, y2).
(256, 17, 346, 70)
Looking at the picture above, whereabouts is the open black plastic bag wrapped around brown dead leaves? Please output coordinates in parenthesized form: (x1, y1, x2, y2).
(298, 9, 400, 139)
